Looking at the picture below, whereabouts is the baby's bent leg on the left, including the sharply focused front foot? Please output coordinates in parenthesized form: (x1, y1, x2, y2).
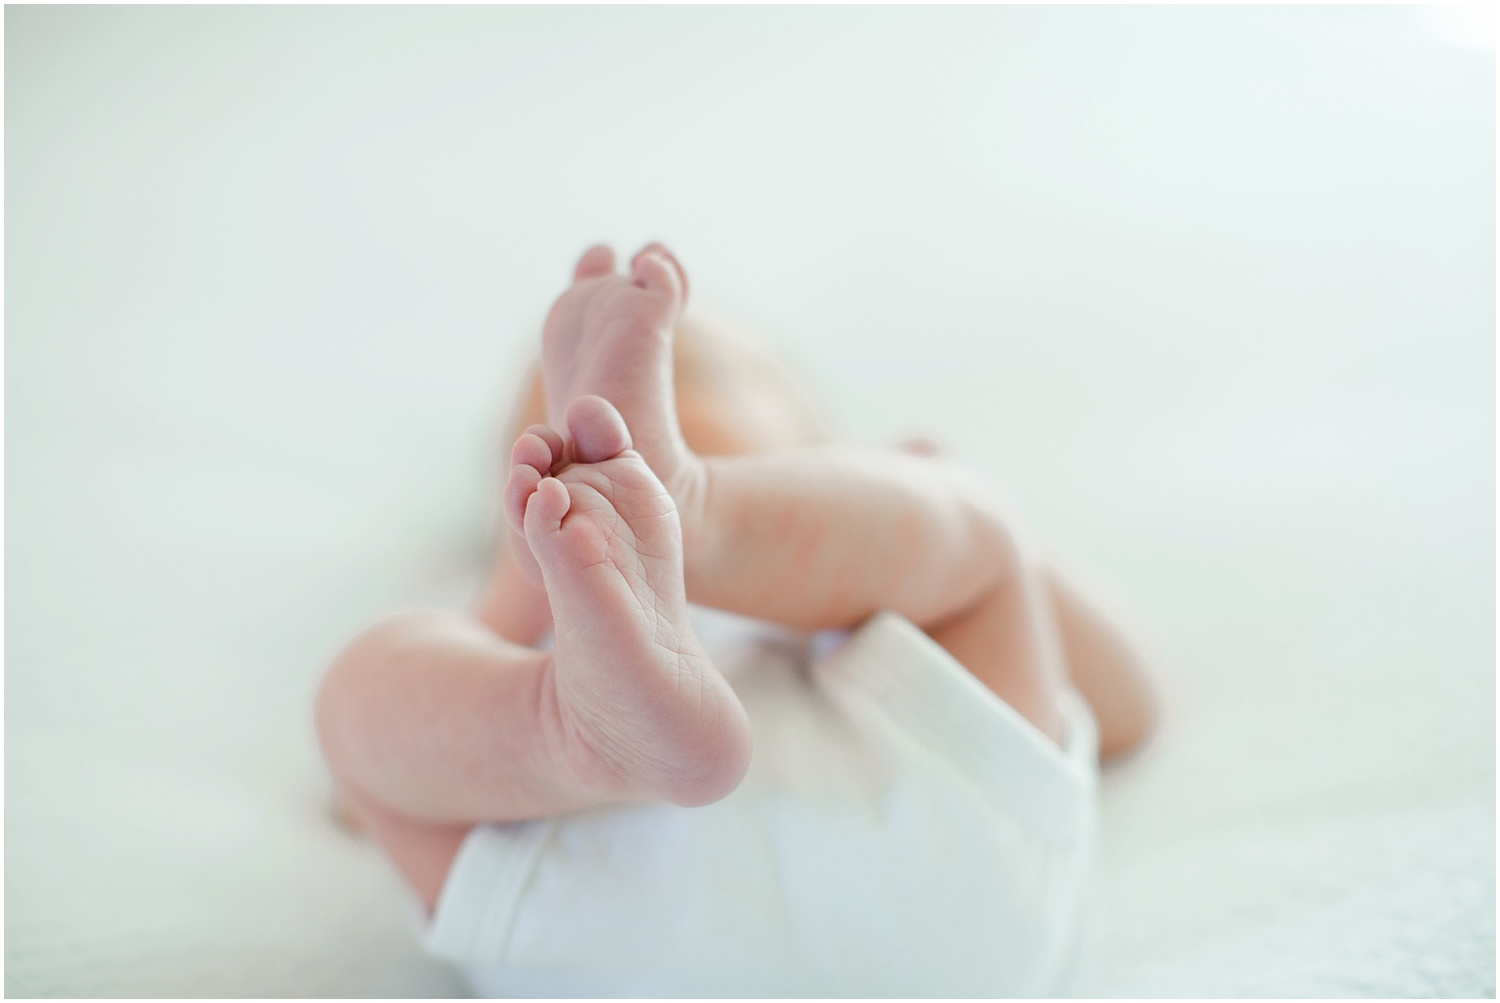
(318, 397, 750, 851)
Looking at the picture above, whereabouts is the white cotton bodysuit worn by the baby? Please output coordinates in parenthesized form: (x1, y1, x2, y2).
(428, 602, 1097, 997)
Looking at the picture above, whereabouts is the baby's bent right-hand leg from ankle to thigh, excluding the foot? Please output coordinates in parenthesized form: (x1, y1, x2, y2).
(687, 448, 1067, 739)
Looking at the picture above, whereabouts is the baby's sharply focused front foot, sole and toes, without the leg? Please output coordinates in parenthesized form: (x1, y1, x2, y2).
(506, 396, 750, 805)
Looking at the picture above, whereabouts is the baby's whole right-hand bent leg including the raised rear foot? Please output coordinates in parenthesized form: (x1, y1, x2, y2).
(543, 244, 1065, 736)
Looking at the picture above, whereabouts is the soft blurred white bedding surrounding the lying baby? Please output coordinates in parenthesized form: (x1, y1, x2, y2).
(5, 7, 1496, 996)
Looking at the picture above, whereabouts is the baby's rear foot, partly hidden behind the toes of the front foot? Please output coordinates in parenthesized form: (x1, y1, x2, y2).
(542, 244, 698, 507)
